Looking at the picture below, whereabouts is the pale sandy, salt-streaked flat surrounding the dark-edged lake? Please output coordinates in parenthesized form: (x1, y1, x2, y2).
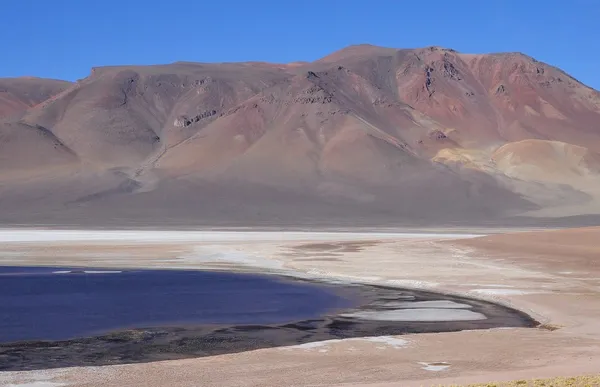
(0, 228, 600, 387)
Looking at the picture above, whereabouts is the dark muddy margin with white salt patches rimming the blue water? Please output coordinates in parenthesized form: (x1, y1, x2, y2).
(0, 266, 539, 371)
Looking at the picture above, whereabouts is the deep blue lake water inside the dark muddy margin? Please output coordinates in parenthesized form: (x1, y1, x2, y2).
(0, 267, 353, 342)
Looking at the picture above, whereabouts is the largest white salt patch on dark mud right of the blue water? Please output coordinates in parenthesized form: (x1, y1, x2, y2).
(342, 308, 487, 322)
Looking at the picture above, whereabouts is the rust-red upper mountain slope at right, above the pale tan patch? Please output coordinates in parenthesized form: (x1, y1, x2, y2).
(322, 46, 600, 152)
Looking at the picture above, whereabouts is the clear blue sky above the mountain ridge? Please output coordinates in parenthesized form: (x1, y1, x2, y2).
(0, 0, 600, 89)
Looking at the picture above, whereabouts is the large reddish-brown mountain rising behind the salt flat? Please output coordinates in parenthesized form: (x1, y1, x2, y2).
(0, 45, 600, 225)
